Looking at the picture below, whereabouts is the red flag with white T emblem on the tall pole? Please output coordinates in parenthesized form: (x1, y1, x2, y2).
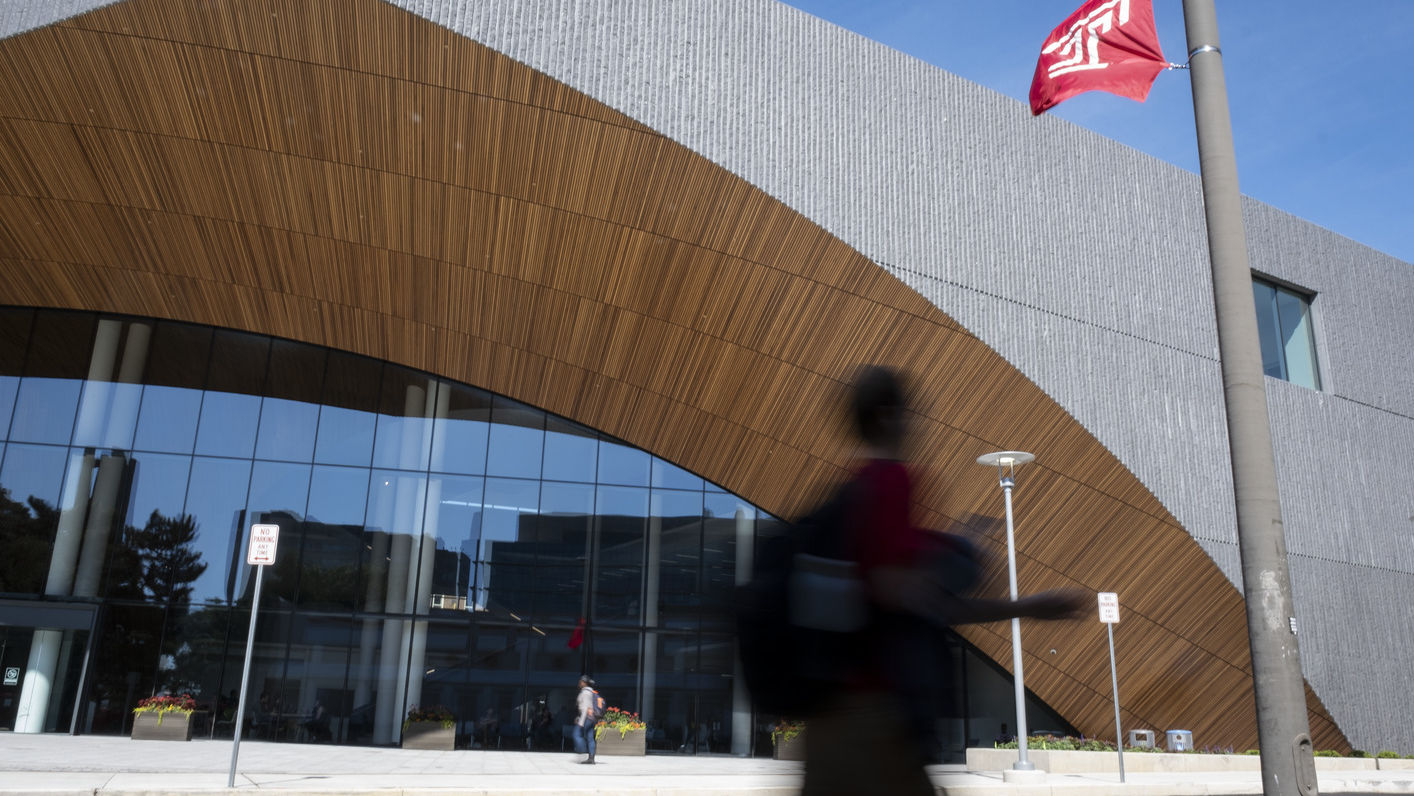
(1031, 0, 1168, 115)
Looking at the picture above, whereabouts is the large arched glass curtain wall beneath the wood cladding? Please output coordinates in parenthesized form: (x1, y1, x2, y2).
(0, 308, 769, 754)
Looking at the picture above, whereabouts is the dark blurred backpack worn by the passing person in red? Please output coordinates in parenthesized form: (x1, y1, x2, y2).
(732, 482, 870, 715)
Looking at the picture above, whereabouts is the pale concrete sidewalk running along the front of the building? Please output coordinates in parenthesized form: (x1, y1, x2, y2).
(0, 732, 1414, 796)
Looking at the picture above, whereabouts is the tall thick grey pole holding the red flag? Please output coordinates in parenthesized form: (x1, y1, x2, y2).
(1184, 0, 1316, 796)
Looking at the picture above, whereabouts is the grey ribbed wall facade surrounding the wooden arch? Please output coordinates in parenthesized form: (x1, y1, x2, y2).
(0, 0, 1414, 752)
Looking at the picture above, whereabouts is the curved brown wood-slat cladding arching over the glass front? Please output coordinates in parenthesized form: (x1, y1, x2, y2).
(0, 0, 1349, 749)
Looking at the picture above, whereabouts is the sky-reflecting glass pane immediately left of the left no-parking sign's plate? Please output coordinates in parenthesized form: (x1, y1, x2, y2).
(187, 457, 250, 602)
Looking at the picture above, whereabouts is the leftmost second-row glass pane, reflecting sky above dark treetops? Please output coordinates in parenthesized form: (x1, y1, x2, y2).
(0, 443, 68, 594)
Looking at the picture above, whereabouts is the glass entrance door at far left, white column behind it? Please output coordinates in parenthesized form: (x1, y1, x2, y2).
(0, 599, 98, 732)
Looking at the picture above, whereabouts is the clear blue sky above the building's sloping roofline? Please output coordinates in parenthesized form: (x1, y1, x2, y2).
(785, 0, 1414, 263)
